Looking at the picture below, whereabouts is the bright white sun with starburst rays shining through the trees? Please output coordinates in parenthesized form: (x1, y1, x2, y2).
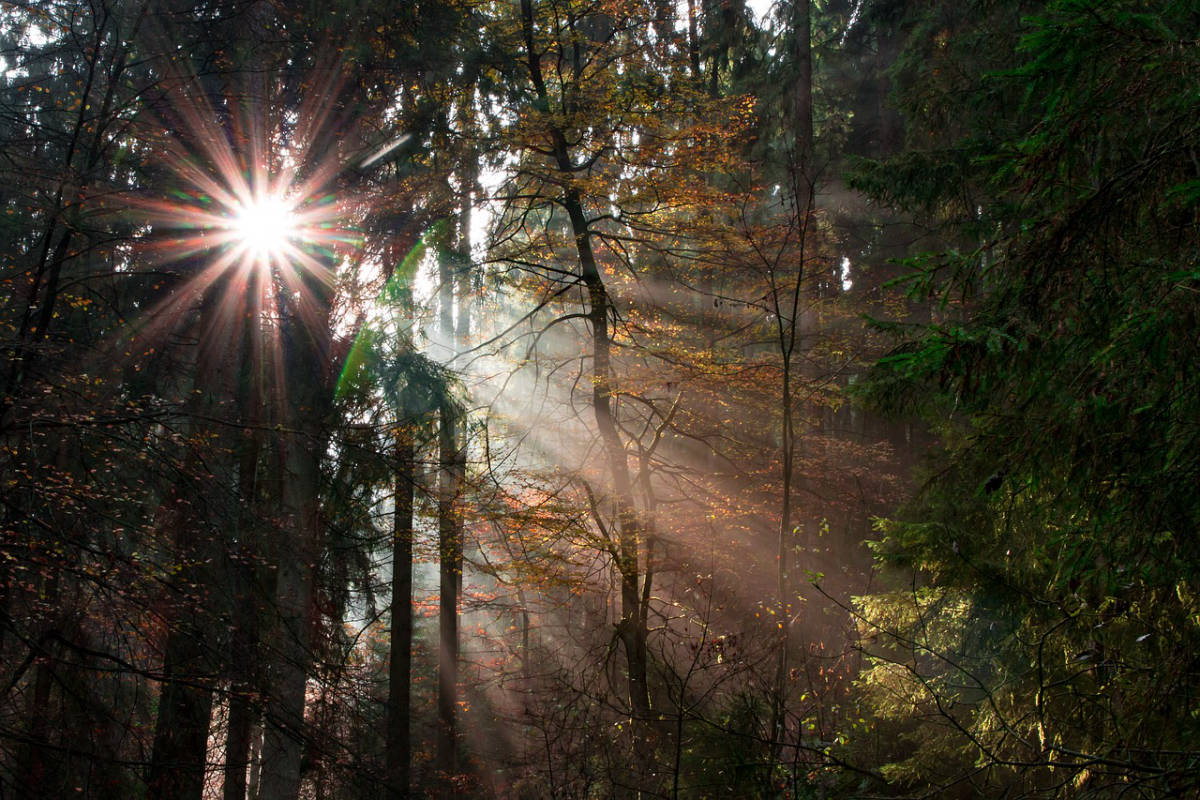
(130, 65, 372, 319)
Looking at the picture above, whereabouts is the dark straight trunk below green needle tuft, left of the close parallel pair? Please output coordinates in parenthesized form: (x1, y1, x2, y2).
(386, 431, 415, 800)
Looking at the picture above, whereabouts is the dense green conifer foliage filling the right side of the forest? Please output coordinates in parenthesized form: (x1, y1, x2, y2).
(858, 0, 1200, 796)
